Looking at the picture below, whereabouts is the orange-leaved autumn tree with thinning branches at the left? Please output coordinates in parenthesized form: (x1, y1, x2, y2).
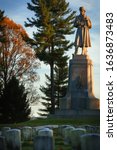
(0, 17, 38, 88)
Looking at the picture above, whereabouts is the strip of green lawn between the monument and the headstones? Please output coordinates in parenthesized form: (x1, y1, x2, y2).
(0, 117, 100, 127)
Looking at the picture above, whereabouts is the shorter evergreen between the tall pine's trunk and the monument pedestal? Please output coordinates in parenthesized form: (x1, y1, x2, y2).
(54, 56, 69, 108)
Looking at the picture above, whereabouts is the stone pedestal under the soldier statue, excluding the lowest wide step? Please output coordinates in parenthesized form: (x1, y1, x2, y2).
(60, 55, 99, 110)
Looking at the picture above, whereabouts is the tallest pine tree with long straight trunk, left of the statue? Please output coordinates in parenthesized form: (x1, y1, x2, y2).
(25, 0, 75, 114)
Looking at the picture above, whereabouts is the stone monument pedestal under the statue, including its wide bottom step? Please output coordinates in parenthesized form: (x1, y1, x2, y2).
(55, 55, 100, 118)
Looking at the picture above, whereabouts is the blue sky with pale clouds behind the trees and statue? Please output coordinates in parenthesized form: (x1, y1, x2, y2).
(0, 0, 100, 115)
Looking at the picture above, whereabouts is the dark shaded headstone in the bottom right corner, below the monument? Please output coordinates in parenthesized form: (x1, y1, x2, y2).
(81, 134, 100, 150)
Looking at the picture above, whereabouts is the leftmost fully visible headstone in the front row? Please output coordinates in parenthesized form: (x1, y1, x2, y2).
(6, 129, 21, 150)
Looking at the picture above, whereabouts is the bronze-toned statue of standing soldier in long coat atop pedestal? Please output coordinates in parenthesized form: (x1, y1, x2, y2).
(74, 7, 92, 55)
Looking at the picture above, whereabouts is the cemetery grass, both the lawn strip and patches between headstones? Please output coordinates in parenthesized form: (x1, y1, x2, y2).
(0, 117, 100, 150)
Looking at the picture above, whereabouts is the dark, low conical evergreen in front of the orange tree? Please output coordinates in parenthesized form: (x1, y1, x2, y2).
(0, 77, 31, 123)
